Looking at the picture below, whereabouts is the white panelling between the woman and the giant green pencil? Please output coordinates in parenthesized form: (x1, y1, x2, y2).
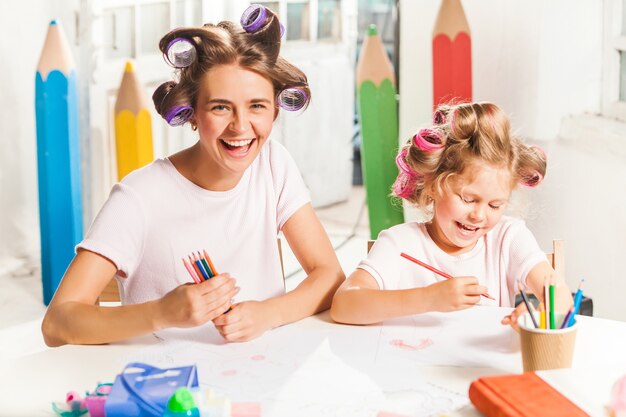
(272, 44, 355, 207)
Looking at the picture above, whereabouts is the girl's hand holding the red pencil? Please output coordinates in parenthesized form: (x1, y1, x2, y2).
(427, 277, 487, 312)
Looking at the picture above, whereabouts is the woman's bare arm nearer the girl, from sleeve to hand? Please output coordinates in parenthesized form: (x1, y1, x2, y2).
(213, 204, 345, 342)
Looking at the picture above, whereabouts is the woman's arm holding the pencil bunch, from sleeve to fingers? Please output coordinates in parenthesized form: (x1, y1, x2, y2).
(41, 250, 237, 346)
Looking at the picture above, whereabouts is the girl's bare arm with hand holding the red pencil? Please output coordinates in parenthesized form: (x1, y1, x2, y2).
(330, 269, 487, 324)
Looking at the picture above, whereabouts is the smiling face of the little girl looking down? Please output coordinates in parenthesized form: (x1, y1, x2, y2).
(428, 166, 512, 255)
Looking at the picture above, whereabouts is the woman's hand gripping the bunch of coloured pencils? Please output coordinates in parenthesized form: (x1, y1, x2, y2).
(157, 274, 239, 328)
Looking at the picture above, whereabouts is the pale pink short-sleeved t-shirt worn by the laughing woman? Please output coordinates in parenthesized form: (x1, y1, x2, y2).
(76, 140, 310, 304)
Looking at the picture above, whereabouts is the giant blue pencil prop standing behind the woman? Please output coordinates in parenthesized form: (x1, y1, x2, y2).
(35, 20, 83, 305)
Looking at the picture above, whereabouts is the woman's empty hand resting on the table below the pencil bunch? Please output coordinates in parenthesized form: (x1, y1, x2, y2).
(213, 301, 275, 342)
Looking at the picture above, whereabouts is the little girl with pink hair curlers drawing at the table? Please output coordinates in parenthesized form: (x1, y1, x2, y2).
(330, 103, 571, 324)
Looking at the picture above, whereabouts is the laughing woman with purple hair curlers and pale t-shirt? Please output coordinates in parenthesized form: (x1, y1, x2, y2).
(42, 5, 344, 346)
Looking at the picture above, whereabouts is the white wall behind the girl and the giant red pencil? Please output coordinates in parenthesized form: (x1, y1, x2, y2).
(400, 0, 626, 320)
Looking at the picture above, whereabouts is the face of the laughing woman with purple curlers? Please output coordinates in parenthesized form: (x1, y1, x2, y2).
(193, 64, 275, 186)
